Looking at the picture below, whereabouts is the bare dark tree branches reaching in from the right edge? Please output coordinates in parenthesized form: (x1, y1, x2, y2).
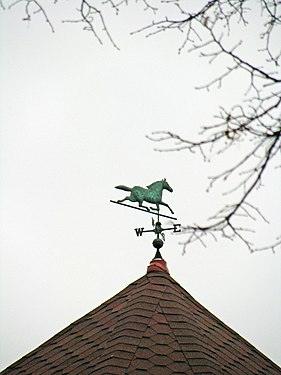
(139, 0, 281, 252)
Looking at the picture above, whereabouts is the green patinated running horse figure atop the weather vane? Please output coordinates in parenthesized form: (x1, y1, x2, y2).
(115, 178, 174, 214)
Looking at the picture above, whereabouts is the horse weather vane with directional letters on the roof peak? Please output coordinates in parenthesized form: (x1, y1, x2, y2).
(110, 178, 181, 258)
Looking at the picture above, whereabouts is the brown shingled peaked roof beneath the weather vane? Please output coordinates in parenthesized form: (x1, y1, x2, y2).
(2, 259, 281, 375)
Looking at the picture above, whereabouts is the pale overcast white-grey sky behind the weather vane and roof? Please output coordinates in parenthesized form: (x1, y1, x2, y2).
(0, 1, 281, 370)
